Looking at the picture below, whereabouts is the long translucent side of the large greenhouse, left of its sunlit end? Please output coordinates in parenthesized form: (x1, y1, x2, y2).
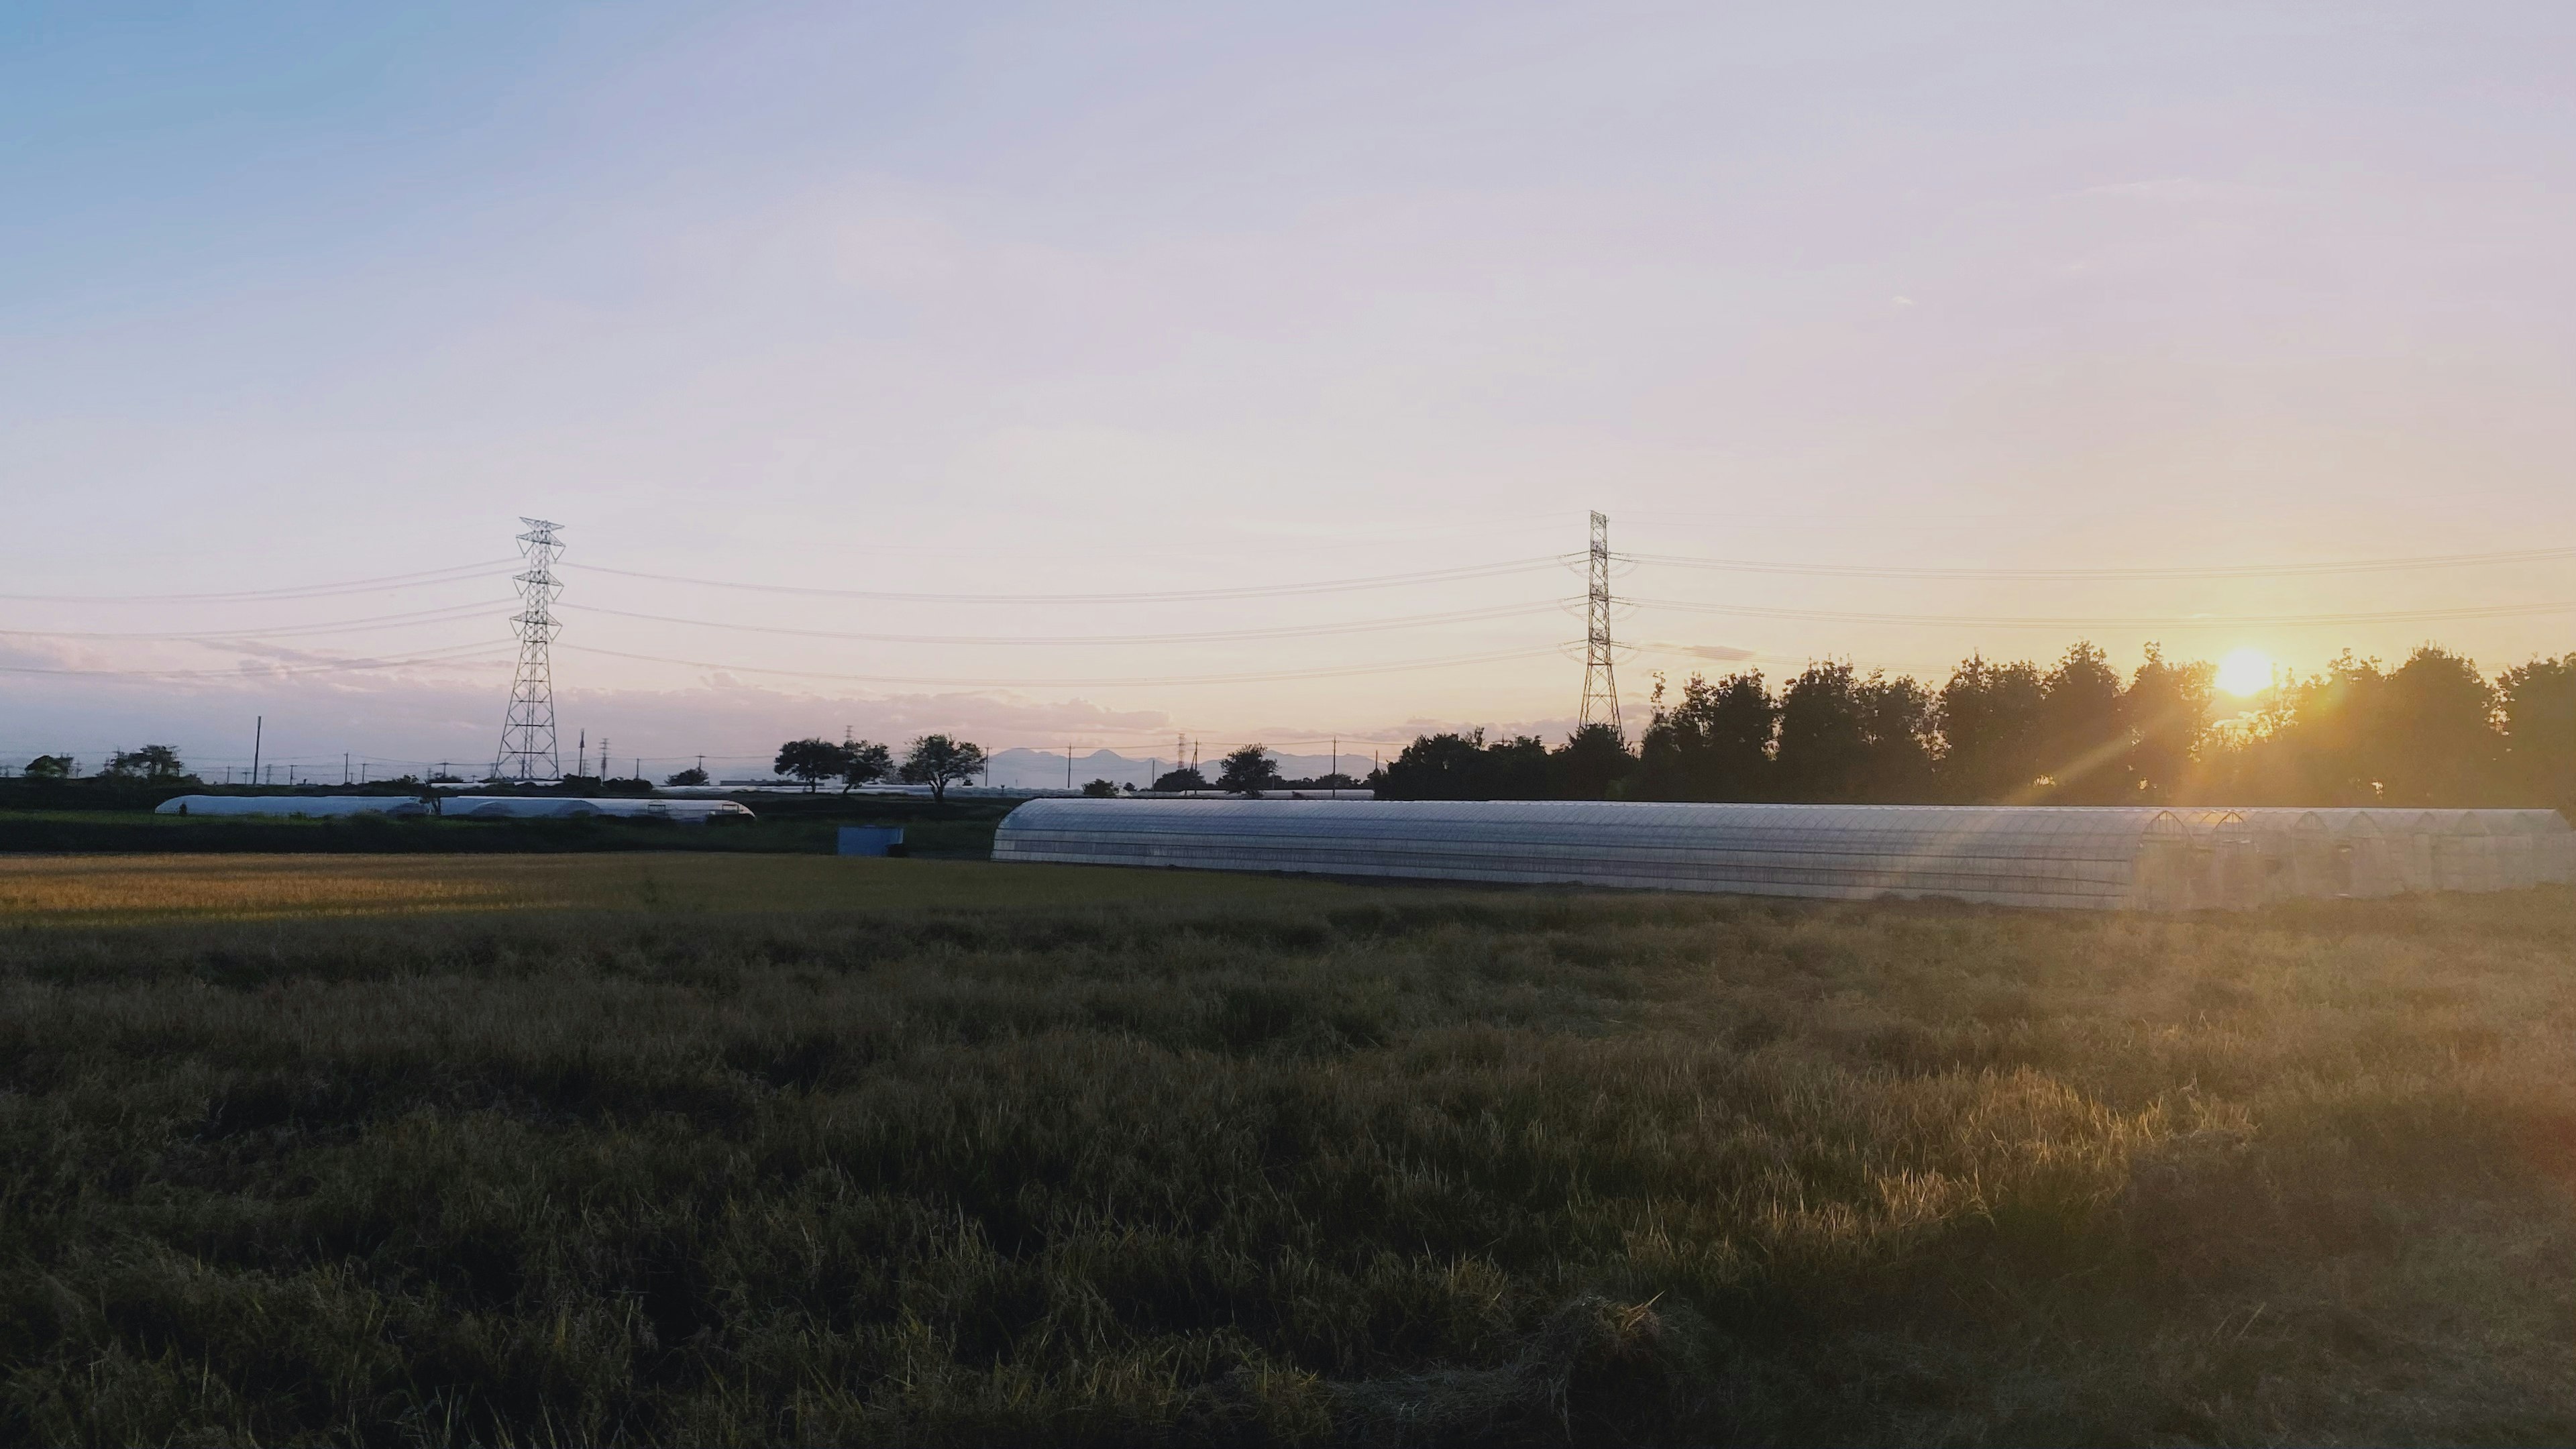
(991, 799, 2200, 908)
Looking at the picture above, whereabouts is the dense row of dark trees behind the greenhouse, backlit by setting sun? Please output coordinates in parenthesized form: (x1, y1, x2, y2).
(1368, 645, 2576, 807)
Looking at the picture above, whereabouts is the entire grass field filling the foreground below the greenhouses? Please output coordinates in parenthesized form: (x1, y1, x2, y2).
(0, 856, 2576, 1444)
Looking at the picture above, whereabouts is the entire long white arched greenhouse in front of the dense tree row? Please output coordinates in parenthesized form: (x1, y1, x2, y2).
(991, 799, 2576, 910)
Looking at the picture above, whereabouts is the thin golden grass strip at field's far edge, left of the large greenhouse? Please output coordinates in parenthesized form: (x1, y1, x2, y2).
(0, 851, 1347, 926)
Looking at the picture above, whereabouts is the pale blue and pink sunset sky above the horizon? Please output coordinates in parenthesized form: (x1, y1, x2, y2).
(0, 3, 2576, 773)
